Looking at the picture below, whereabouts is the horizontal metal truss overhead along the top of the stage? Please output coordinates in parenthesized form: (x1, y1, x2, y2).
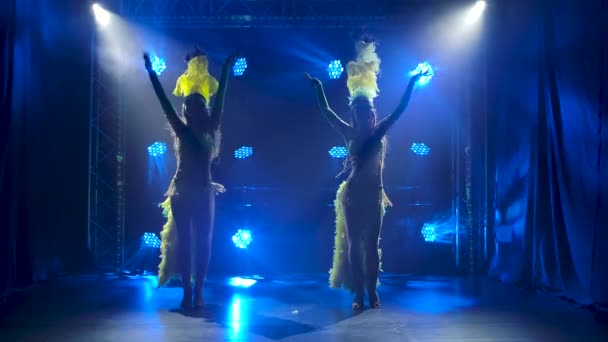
(125, 0, 418, 27)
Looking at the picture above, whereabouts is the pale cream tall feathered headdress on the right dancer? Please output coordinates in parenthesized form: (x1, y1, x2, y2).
(346, 41, 380, 102)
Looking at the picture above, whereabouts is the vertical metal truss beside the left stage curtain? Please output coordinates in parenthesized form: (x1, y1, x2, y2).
(88, 35, 126, 271)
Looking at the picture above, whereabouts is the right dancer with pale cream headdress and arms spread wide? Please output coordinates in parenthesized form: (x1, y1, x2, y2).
(306, 40, 423, 309)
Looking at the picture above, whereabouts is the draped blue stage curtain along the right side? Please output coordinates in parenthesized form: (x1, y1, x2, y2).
(490, 0, 608, 305)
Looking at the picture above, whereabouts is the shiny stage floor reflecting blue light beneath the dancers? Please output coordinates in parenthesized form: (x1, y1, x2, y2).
(0, 275, 608, 342)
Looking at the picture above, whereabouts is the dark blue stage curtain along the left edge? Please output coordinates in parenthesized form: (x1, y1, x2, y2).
(0, 0, 92, 293)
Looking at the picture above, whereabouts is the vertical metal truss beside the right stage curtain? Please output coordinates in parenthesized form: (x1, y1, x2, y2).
(453, 48, 493, 274)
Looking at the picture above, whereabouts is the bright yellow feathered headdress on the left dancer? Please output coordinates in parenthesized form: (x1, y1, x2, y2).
(173, 48, 218, 103)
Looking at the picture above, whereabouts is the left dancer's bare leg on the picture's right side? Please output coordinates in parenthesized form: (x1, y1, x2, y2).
(194, 190, 215, 308)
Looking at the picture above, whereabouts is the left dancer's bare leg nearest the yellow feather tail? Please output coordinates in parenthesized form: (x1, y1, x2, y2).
(171, 196, 192, 309)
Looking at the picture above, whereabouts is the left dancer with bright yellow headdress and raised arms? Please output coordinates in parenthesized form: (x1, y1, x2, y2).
(144, 49, 235, 308)
